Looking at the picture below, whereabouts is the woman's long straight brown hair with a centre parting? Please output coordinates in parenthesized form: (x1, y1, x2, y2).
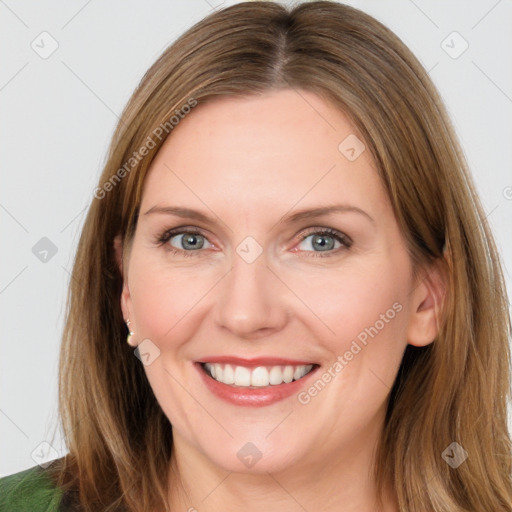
(46, 1, 512, 512)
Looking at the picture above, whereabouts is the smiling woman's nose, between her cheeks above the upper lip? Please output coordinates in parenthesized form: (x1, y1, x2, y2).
(215, 249, 289, 339)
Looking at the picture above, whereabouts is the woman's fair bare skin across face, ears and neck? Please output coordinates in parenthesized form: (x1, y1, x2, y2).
(115, 90, 442, 512)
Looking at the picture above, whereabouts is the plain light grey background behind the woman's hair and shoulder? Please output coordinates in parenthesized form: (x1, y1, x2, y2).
(0, 0, 512, 476)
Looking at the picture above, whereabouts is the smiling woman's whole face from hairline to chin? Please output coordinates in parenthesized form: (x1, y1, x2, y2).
(122, 90, 432, 472)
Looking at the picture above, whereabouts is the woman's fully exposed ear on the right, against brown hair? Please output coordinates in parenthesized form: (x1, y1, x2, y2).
(407, 258, 447, 347)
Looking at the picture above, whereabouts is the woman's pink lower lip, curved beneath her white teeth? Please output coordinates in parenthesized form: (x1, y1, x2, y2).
(195, 363, 318, 407)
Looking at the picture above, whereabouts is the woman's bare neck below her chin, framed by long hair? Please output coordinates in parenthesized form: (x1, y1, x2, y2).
(169, 412, 398, 512)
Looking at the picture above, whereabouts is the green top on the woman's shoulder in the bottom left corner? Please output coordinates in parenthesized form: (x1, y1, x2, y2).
(0, 466, 62, 512)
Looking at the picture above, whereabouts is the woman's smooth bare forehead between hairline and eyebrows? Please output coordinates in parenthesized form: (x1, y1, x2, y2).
(141, 89, 386, 220)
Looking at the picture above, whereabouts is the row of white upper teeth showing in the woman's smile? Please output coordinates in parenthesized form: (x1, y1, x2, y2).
(204, 363, 313, 387)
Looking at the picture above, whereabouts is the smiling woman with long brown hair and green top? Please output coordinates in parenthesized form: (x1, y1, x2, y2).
(1, 2, 512, 512)
